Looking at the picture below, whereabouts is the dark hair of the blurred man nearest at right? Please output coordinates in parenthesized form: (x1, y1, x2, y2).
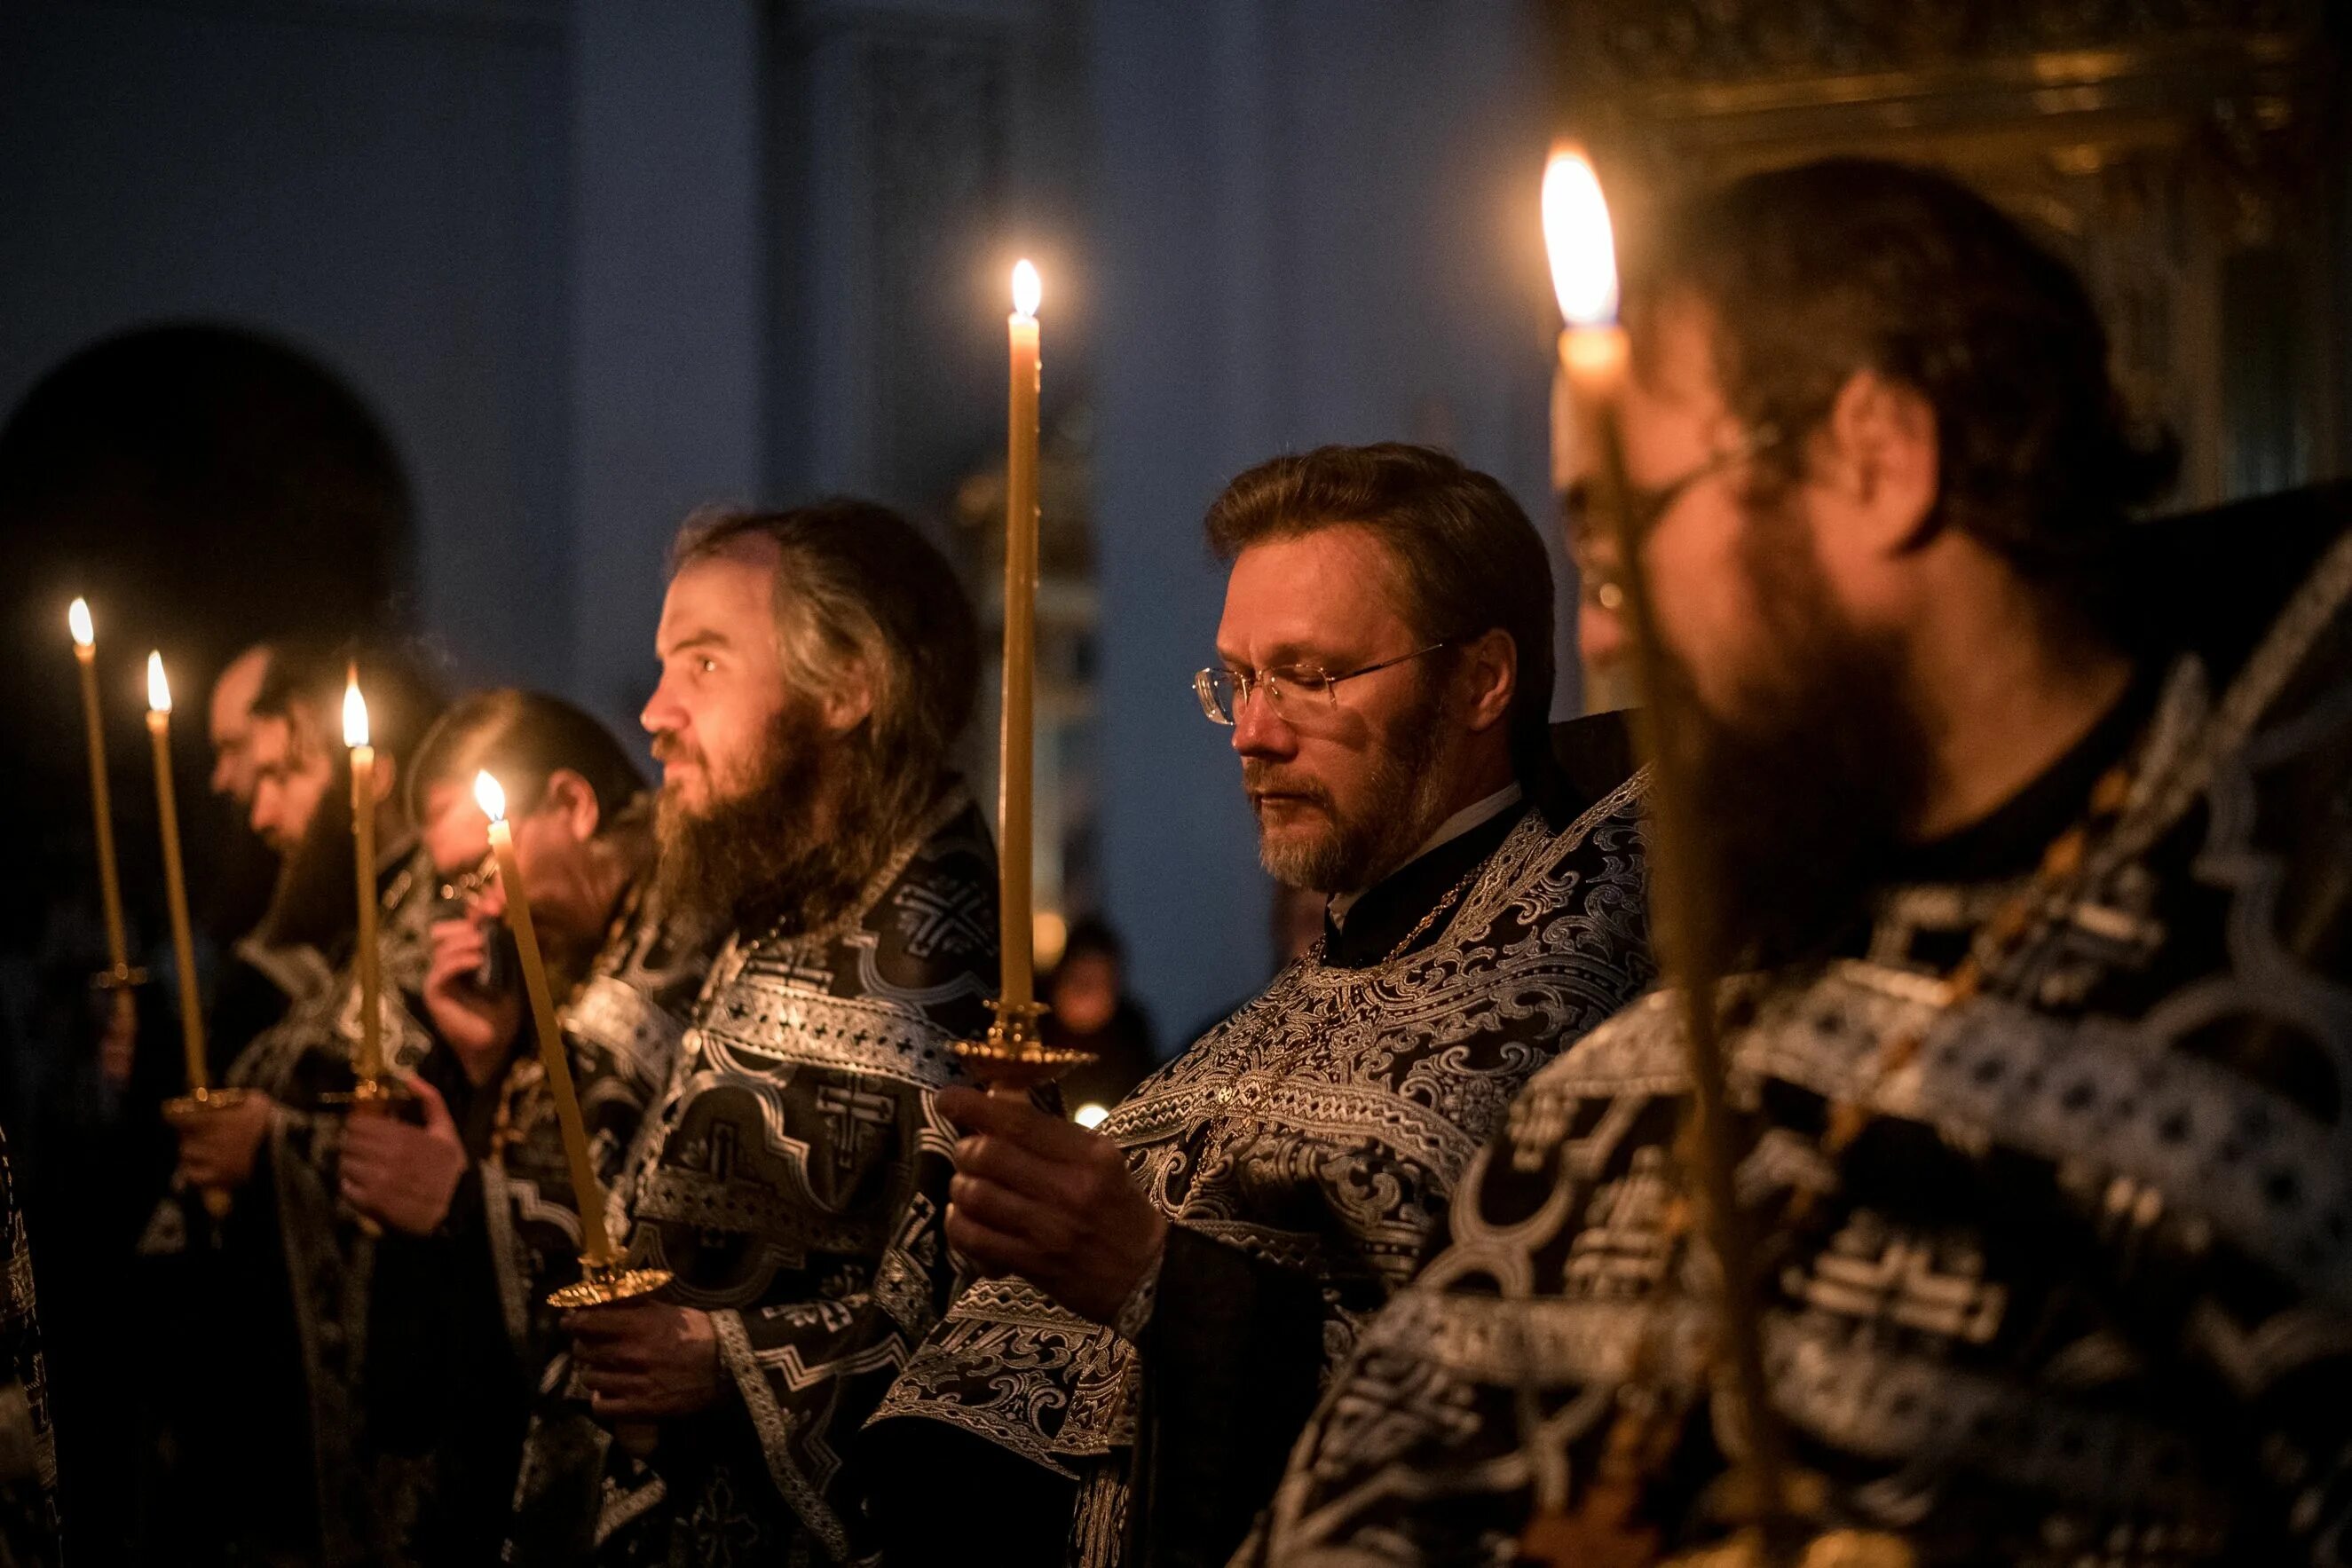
(1628, 157, 2178, 616)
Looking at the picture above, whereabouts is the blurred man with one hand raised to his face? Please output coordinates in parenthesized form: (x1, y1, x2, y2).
(341, 691, 708, 1564)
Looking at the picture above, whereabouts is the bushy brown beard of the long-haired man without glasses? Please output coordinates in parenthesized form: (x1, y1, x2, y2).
(654, 705, 936, 934)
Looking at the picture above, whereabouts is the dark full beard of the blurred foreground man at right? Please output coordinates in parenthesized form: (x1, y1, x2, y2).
(1663, 510, 1929, 968)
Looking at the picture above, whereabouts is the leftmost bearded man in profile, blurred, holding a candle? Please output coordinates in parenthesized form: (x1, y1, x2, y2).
(144, 647, 440, 1564)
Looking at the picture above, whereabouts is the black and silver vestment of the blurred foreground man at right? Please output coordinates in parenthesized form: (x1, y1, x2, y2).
(1247, 489, 2352, 1568)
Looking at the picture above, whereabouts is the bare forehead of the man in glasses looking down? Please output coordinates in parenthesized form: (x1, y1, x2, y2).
(1216, 522, 1421, 670)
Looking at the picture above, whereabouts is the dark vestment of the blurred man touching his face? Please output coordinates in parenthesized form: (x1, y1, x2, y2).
(367, 879, 710, 1565)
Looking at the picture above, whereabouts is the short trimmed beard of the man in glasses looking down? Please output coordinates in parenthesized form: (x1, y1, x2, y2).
(1242, 680, 1447, 894)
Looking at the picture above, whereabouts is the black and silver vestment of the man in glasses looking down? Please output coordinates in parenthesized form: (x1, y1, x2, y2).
(868, 720, 1651, 1565)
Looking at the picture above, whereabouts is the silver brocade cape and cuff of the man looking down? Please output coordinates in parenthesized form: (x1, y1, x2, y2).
(875, 781, 1651, 1564)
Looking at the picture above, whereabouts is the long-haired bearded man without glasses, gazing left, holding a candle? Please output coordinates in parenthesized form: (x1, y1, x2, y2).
(564, 500, 998, 1564)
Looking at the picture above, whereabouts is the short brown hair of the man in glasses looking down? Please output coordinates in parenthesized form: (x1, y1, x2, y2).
(1206, 442, 1552, 783)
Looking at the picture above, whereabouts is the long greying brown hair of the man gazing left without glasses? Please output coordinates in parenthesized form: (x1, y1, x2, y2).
(670, 499, 978, 828)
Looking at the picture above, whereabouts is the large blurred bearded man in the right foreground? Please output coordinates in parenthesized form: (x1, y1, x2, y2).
(1247, 160, 2352, 1565)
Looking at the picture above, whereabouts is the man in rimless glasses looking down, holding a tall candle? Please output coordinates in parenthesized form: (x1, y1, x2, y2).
(868, 445, 1651, 1565)
